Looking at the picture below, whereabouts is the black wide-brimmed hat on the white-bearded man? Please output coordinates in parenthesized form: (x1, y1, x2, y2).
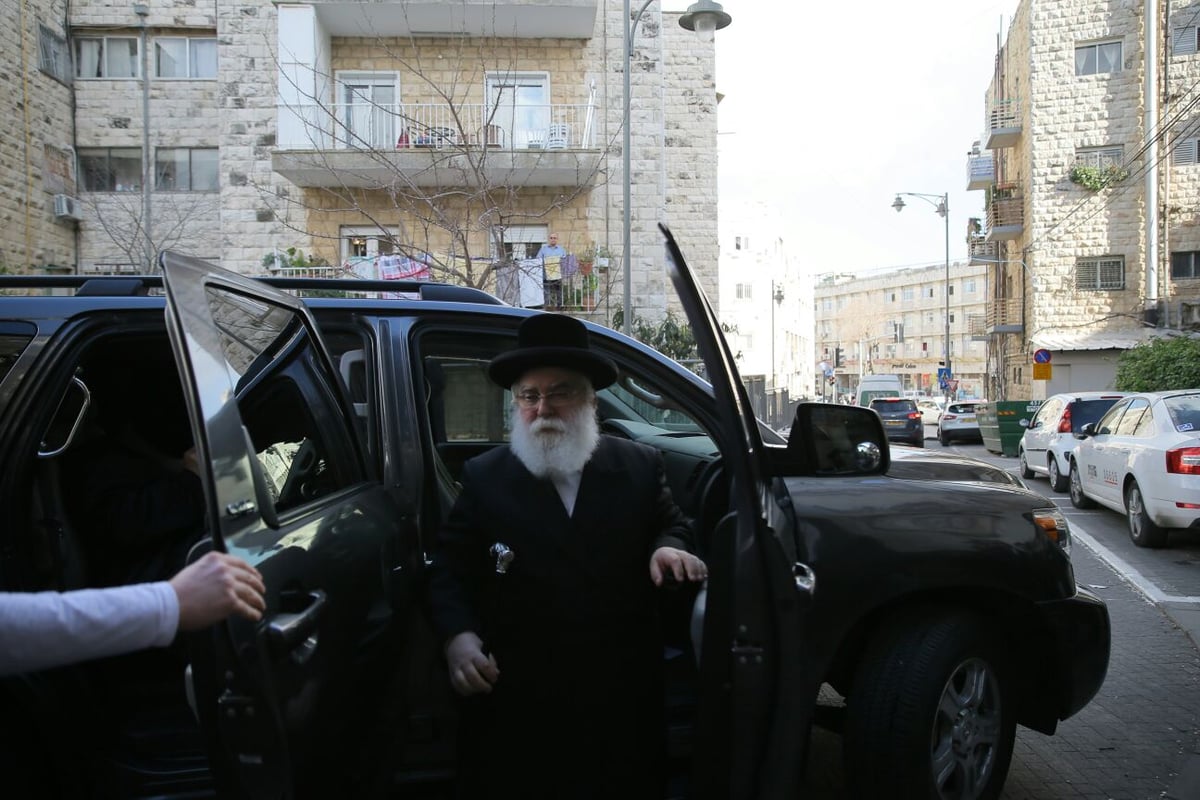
(487, 314, 617, 389)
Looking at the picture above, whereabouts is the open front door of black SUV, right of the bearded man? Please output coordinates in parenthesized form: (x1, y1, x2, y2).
(660, 225, 815, 799)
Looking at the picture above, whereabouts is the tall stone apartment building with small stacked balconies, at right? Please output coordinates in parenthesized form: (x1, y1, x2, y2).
(967, 0, 1200, 399)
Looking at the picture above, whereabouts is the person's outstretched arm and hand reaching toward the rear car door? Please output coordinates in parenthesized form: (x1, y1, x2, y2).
(0, 553, 266, 675)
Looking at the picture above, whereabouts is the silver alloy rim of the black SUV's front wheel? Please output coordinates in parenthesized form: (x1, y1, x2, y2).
(930, 658, 1002, 800)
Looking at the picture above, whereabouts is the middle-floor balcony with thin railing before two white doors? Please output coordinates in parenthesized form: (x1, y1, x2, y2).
(271, 103, 602, 188)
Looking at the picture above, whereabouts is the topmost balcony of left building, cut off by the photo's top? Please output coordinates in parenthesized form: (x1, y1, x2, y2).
(314, 0, 600, 38)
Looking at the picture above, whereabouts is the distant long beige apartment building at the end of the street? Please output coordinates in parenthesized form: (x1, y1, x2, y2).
(815, 263, 994, 399)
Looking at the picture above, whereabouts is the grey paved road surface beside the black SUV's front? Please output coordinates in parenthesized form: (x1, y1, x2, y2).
(805, 443, 1200, 800)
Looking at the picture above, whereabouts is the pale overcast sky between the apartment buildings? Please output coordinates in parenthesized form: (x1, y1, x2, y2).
(667, 0, 1018, 273)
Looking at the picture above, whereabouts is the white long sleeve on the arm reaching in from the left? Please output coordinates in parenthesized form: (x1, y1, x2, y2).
(0, 581, 179, 675)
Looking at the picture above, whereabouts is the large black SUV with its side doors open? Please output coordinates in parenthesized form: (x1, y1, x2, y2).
(0, 234, 1109, 799)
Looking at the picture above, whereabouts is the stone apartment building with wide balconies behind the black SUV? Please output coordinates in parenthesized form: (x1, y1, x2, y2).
(0, 0, 718, 320)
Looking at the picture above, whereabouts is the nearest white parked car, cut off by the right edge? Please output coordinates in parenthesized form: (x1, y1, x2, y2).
(1069, 390, 1200, 547)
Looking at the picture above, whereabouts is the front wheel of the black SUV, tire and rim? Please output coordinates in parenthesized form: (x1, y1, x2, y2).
(842, 608, 1016, 800)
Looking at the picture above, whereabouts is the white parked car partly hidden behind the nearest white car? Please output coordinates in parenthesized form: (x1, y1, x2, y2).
(1016, 391, 1128, 492)
